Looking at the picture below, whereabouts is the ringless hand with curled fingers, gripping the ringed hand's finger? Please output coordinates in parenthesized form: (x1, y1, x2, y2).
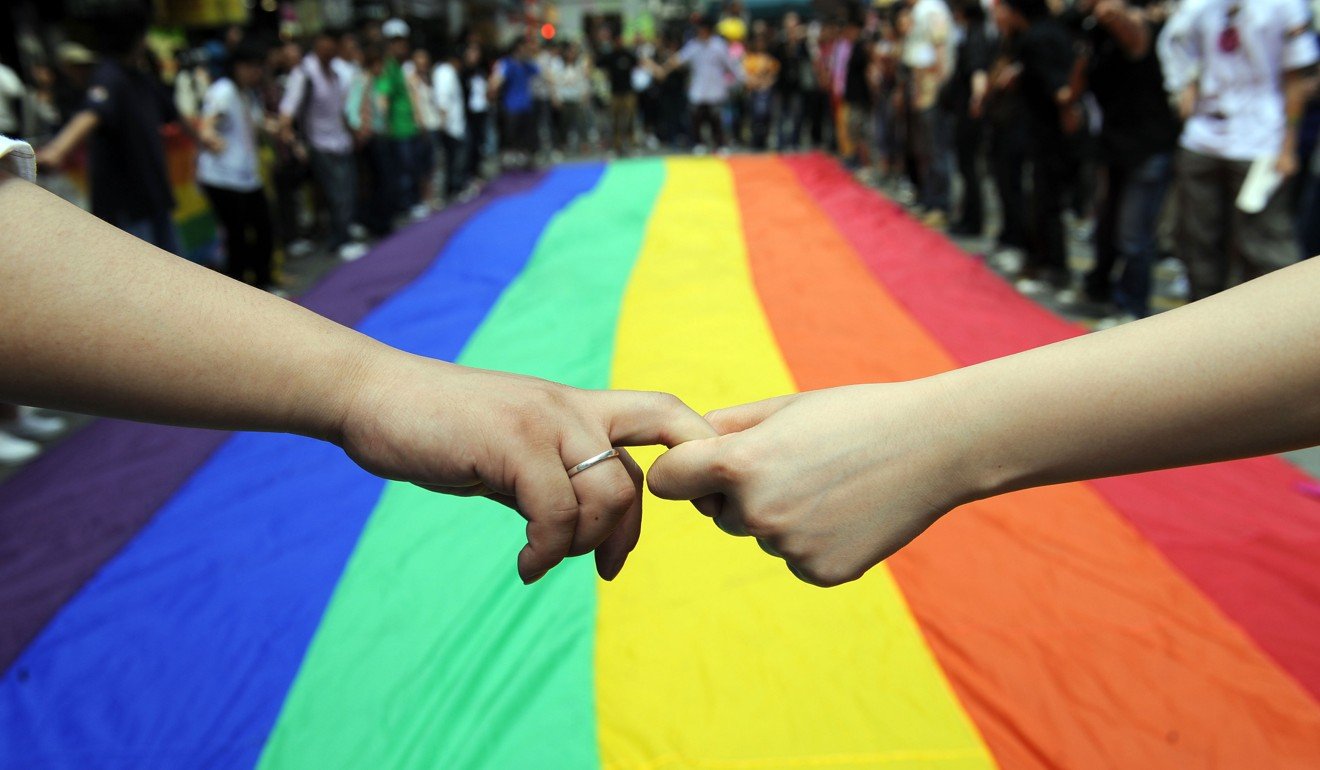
(648, 380, 975, 586)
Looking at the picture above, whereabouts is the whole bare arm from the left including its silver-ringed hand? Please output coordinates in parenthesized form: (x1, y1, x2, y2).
(0, 172, 714, 582)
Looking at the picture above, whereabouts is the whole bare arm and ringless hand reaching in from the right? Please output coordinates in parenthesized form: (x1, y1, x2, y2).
(649, 259, 1320, 585)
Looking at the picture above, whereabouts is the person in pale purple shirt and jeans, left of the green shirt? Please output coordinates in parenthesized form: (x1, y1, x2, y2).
(280, 30, 367, 262)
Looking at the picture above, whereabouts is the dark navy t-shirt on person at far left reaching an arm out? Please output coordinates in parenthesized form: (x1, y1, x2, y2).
(84, 61, 178, 223)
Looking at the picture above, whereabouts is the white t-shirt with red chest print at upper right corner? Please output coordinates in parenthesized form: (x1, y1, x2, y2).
(1159, 0, 1320, 161)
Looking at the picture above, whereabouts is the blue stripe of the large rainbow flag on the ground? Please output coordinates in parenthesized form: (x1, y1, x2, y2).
(0, 165, 603, 770)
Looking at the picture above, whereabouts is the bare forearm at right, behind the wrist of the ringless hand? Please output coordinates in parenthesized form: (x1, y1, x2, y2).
(936, 260, 1320, 495)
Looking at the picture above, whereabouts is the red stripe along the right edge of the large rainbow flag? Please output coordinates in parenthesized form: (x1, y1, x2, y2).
(785, 149, 1320, 697)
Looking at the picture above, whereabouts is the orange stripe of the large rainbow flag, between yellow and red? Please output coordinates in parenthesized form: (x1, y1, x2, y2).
(731, 153, 1320, 769)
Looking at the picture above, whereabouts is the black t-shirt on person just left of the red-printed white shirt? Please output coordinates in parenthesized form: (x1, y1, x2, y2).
(1080, 6, 1181, 162)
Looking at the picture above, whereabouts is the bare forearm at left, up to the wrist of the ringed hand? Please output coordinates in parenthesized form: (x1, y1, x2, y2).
(0, 176, 383, 438)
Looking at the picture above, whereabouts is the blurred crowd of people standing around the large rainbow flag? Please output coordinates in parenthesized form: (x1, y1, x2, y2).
(0, 0, 1320, 462)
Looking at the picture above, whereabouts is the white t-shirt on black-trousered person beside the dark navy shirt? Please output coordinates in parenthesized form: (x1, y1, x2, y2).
(197, 78, 261, 193)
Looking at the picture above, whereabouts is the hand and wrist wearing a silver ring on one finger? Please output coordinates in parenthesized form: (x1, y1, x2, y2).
(335, 350, 715, 584)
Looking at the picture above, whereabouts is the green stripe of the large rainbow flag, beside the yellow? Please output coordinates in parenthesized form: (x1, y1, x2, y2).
(260, 161, 664, 770)
